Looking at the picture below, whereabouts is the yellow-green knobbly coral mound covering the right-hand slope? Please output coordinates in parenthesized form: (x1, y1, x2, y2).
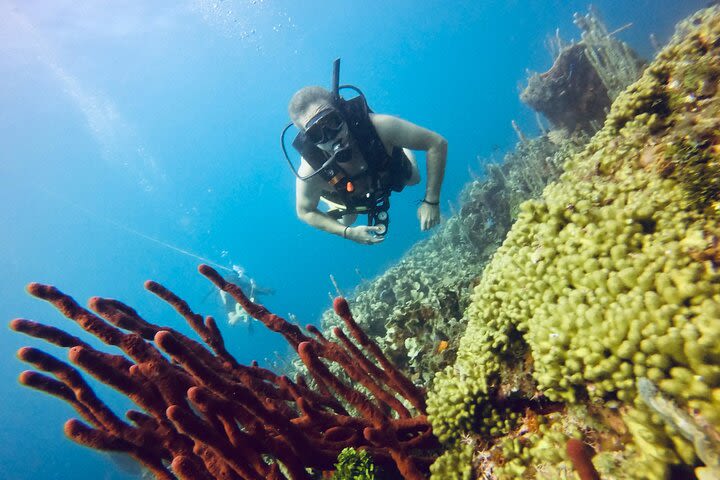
(428, 7, 720, 478)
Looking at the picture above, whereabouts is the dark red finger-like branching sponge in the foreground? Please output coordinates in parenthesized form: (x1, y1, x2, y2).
(10, 265, 437, 480)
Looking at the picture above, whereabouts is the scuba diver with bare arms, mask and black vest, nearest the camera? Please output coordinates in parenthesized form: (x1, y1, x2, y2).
(281, 59, 447, 245)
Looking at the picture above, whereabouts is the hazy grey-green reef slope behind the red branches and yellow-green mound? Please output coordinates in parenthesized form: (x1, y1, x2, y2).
(318, 132, 585, 385)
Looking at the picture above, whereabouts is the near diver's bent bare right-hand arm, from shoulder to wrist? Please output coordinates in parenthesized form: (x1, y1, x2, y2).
(372, 114, 447, 202)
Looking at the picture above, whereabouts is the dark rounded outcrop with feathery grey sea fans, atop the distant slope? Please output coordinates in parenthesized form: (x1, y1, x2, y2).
(520, 8, 645, 132)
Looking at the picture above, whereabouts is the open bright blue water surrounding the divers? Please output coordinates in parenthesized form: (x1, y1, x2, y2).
(0, 0, 707, 480)
